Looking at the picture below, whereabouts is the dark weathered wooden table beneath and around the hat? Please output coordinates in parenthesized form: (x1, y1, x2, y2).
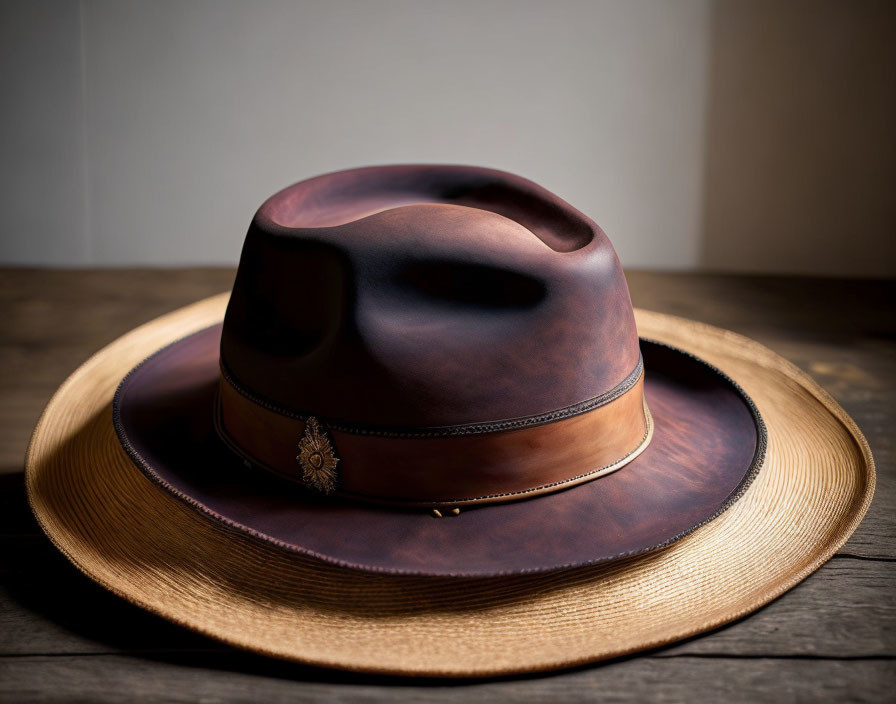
(0, 269, 896, 702)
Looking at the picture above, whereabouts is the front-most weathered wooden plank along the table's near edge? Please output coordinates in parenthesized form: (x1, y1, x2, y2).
(0, 653, 896, 704)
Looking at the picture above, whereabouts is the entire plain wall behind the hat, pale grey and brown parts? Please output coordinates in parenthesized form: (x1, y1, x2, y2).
(0, 0, 896, 276)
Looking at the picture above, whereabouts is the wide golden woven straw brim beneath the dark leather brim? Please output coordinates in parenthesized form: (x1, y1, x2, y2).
(26, 295, 874, 676)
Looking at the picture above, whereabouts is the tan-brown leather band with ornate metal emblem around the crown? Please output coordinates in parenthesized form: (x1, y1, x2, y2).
(215, 363, 653, 507)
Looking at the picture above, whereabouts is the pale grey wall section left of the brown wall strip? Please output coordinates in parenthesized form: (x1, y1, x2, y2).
(0, 0, 708, 268)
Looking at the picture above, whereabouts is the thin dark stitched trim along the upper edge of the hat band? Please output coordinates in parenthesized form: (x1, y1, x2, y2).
(220, 350, 644, 438)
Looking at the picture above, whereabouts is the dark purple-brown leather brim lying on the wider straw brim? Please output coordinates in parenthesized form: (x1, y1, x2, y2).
(113, 324, 765, 577)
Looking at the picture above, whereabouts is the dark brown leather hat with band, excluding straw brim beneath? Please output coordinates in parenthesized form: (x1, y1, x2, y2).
(115, 166, 765, 575)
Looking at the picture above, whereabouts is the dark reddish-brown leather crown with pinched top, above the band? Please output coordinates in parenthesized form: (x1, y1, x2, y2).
(221, 166, 640, 428)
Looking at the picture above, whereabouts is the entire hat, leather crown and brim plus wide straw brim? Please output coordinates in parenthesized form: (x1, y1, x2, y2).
(26, 166, 874, 676)
